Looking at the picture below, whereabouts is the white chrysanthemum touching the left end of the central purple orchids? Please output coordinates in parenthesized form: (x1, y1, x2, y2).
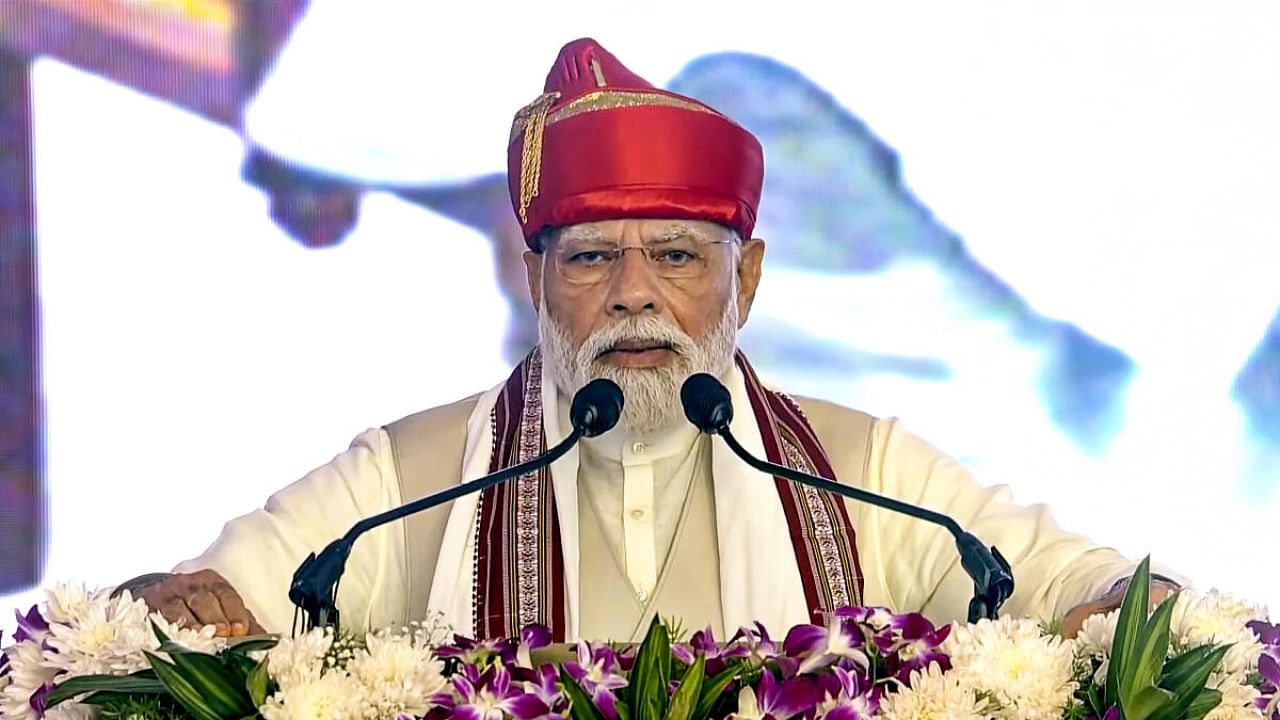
(347, 632, 444, 717)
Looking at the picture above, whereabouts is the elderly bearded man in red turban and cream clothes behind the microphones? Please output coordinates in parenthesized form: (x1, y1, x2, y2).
(127, 40, 1172, 641)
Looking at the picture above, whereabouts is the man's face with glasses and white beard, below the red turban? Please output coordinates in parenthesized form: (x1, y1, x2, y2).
(525, 219, 764, 432)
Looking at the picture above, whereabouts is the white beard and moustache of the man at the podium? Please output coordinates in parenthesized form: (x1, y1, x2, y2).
(538, 293, 737, 436)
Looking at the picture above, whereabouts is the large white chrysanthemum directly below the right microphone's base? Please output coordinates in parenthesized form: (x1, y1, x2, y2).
(942, 618, 1076, 720)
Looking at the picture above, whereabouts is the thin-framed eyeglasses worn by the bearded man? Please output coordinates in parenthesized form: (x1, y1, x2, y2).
(552, 240, 735, 284)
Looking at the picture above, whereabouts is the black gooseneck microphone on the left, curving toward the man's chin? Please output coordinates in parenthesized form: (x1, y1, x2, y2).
(289, 378, 622, 634)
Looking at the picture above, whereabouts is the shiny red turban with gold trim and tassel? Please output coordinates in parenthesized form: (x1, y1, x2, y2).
(507, 38, 764, 250)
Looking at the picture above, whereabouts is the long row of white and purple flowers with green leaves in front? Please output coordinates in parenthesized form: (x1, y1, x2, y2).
(0, 562, 1280, 720)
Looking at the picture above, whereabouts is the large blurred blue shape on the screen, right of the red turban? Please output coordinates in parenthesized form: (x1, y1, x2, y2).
(669, 53, 1134, 450)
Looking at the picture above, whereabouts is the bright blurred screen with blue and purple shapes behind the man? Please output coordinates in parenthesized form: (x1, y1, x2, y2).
(0, 0, 1280, 622)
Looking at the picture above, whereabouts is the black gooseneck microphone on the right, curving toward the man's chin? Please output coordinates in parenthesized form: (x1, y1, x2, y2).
(680, 373, 1014, 623)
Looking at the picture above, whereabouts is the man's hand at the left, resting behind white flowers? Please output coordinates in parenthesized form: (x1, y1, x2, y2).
(120, 570, 265, 638)
